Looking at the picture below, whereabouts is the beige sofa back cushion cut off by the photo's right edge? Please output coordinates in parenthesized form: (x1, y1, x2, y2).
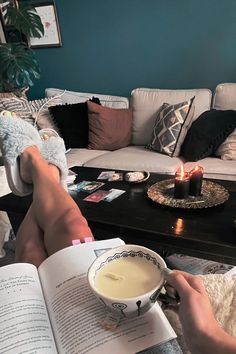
(212, 83, 236, 110)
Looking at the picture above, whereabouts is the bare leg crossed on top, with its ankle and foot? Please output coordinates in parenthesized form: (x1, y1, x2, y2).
(20, 146, 93, 255)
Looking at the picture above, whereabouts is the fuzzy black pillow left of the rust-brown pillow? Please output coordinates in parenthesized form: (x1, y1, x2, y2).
(48, 97, 100, 149)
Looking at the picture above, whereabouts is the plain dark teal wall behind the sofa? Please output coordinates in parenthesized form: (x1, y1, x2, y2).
(30, 0, 236, 98)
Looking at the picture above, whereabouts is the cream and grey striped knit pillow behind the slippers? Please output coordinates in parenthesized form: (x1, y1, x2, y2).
(0, 96, 62, 130)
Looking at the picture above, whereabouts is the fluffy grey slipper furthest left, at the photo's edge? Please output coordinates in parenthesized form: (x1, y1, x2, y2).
(0, 115, 42, 196)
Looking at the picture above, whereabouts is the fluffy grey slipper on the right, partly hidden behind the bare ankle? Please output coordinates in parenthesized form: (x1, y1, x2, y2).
(41, 135, 68, 190)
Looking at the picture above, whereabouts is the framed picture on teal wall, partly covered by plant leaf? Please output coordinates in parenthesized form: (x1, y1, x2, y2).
(29, 1, 62, 48)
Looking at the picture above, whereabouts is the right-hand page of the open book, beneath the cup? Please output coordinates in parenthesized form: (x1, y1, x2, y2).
(39, 239, 176, 354)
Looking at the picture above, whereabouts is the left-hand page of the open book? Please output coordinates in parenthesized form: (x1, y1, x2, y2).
(0, 263, 57, 354)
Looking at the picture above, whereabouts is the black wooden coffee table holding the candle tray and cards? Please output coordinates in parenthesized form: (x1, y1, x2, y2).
(0, 167, 236, 265)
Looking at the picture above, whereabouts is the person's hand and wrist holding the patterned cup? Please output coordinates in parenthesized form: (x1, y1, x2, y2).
(166, 270, 236, 354)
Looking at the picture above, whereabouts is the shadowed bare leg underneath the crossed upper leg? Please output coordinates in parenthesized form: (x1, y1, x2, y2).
(15, 207, 47, 267)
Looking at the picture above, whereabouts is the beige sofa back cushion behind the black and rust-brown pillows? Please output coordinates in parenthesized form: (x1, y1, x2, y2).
(45, 88, 129, 108)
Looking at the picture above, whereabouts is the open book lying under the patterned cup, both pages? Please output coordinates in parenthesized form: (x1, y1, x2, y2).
(0, 238, 176, 354)
